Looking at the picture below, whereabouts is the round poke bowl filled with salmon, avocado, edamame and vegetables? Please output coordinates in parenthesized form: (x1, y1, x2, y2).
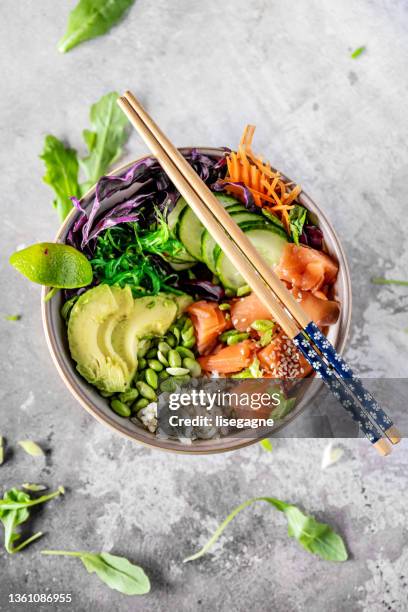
(42, 135, 351, 454)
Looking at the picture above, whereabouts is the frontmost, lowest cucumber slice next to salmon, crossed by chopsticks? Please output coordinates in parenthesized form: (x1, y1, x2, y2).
(214, 225, 288, 290)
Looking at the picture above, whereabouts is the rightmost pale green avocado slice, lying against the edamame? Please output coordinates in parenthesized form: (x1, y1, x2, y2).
(112, 295, 177, 374)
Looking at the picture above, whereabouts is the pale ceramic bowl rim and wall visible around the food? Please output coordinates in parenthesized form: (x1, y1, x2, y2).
(42, 147, 351, 454)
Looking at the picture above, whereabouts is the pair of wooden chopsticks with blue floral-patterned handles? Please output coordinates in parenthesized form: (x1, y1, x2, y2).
(118, 92, 400, 455)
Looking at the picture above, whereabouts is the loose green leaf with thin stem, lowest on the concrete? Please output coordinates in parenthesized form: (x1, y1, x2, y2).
(41, 550, 150, 595)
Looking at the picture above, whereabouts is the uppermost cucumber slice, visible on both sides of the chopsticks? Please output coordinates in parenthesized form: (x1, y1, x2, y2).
(175, 193, 241, 260)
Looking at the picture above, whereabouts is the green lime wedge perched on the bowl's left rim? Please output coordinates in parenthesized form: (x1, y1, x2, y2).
(9, 242, 92, 289)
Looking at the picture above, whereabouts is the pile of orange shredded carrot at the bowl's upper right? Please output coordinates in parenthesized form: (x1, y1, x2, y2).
(225, 125, 301, 230)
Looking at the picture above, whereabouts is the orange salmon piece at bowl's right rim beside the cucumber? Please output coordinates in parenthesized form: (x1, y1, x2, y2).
(275, 243, 339, 291)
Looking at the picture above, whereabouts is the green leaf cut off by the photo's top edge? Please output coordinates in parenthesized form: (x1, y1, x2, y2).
(58, 0, 134, 53)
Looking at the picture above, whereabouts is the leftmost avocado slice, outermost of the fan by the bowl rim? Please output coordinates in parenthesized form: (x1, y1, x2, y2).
(68, 285, 128, 392)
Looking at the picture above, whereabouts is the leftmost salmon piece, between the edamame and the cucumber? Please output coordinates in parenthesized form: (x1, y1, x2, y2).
(187, 300, 231, 355)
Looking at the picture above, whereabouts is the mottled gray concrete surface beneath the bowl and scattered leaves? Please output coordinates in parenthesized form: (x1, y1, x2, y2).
(0, 0, 408, 612)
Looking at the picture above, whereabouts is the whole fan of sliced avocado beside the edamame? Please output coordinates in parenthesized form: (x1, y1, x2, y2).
(68, 284, 182, 393)
